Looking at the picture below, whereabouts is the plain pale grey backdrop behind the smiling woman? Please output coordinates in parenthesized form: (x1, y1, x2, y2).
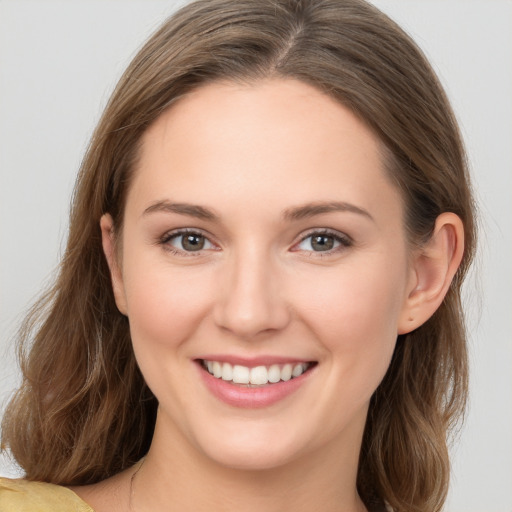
(0, 0, 512, 512)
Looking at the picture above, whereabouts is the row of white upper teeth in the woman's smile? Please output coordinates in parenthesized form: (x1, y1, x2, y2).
(203, 361, 309, 386)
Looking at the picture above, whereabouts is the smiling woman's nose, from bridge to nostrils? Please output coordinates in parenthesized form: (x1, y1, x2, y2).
(214, 250, 290, 339)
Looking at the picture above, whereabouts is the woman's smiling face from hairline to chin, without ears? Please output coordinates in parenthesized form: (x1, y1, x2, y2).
(103, 80, 412, 468)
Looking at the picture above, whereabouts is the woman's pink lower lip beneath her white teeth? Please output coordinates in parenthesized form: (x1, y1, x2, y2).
(197, 364, 313, 409)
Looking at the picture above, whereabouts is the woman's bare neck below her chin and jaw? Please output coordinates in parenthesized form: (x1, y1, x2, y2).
(133, 408, 366, 512)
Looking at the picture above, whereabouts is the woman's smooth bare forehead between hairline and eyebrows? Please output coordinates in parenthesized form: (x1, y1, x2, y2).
(129, 79, 401, 223)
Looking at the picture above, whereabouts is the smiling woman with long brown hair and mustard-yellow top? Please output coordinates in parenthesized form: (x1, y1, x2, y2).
(0, 0, 474, 512)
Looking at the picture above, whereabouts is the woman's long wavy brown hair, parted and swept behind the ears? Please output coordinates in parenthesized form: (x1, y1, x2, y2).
(2, 0, 475, 512)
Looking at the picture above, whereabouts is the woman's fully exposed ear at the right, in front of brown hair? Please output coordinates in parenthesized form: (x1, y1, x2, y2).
(398, 212, 464, 334)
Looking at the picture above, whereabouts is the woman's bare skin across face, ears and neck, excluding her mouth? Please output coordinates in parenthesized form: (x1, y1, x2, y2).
(75, 80, 463, 512)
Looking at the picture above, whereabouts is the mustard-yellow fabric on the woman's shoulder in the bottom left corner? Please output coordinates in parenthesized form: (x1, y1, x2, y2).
(0, 477, 94, 512)
